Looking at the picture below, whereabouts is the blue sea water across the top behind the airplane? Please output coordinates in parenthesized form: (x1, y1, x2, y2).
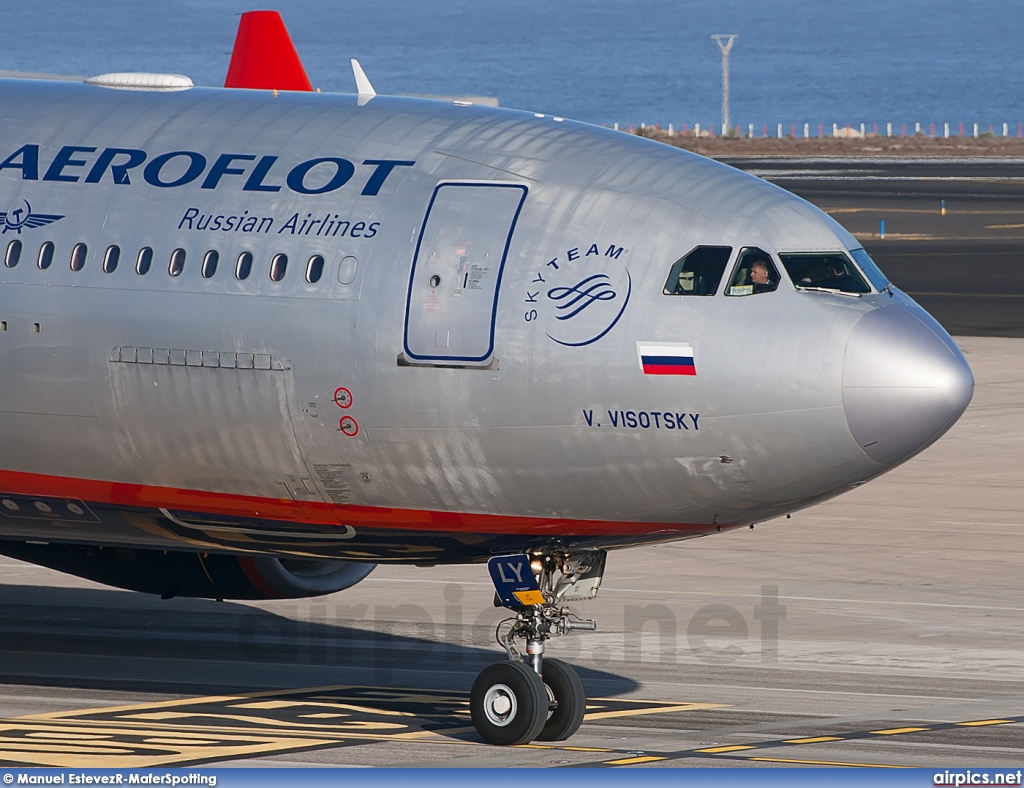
(0, 0, 1024, 134)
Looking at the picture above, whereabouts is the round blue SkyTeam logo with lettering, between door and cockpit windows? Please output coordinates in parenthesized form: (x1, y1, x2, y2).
(524, 243, 633, 347)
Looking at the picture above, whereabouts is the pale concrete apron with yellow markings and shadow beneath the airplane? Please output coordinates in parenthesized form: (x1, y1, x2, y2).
(0, 338, 1024, 768)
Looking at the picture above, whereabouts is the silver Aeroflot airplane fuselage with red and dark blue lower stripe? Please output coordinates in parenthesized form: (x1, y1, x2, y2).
(0, 81, 973, 563)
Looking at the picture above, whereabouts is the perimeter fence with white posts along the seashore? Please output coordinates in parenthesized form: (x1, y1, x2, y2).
(612, 122, 1024, 139)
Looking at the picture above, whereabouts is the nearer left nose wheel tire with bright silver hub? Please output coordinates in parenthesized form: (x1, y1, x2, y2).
(469, 662, 548, 745)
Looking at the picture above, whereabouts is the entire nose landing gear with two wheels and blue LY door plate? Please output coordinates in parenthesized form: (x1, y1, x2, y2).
(469, 549, 606, 744)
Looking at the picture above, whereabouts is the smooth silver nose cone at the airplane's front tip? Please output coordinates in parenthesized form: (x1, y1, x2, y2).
(843, 304, 974, 465)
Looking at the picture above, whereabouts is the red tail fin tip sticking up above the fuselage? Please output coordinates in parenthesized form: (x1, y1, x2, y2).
(224, 11, 313, 91)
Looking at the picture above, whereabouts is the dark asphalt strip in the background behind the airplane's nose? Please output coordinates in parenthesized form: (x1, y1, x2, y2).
(722, 157, 1024, 337)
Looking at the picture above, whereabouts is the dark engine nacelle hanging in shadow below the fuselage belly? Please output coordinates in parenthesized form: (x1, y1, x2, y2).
(0, 541, 376, 600)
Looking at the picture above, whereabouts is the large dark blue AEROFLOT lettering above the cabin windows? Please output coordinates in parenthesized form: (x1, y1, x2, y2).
(0, 144, 416, 196)
